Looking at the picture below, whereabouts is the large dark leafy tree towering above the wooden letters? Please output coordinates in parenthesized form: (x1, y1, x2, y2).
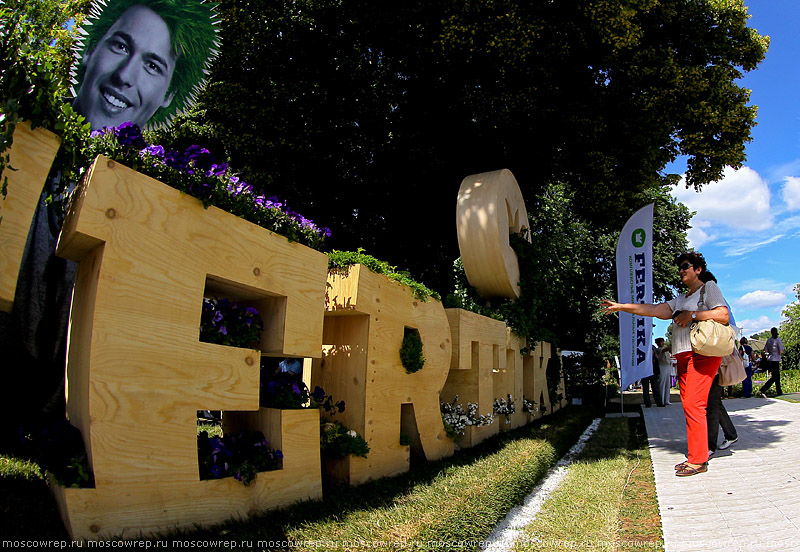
(150, 0, 767, 298)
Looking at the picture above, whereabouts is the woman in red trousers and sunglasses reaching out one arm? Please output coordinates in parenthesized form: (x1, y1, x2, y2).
(603, 251, 729, 476)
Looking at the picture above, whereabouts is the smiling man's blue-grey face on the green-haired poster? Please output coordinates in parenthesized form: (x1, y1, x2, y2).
(72, 5, 177, 130)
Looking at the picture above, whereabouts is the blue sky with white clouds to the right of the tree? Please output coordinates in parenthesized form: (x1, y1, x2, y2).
(653, 0, 800, 338)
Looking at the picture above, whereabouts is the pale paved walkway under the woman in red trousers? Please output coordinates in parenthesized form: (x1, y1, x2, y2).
(642, 398, 800, 552)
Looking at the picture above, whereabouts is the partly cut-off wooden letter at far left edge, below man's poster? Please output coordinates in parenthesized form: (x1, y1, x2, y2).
(0, 123, 59, 312)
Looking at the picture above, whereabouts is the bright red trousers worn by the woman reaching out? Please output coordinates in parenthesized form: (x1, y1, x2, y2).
(675, 351, 722, 464)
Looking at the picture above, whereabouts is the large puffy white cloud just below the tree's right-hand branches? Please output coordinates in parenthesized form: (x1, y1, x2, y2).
(673, 167, 773, 232)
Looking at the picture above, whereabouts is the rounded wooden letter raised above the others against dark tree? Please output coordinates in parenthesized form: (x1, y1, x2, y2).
(456, 169, 528, 299)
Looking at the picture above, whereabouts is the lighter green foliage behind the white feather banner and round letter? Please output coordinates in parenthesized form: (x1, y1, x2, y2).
(445, 184, 691, 383)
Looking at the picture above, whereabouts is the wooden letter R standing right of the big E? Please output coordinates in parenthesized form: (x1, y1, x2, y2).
(312, 265, 453, 484)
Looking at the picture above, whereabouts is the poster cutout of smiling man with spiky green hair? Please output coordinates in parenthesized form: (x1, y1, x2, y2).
(72, 0, 219, 130)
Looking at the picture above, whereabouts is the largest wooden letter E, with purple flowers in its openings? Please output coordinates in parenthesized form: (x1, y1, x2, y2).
(51, 157, 327, 538)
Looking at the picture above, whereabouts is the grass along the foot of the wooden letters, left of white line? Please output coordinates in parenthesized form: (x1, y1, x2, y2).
(0, 407, 616, 550)
